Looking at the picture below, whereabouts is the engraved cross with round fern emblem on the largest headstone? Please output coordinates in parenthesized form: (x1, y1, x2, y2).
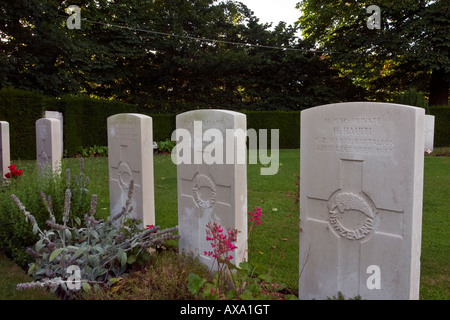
(306, 159, 403, 293)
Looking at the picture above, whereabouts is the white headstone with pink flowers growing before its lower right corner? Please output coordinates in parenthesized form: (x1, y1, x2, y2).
(172, 110, 247, 267)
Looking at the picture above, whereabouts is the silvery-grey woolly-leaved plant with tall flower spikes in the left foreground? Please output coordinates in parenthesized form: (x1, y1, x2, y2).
(12, 180, 179, 298)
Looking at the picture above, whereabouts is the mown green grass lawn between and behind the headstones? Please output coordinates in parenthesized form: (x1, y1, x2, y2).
(0, 150, 450, 300)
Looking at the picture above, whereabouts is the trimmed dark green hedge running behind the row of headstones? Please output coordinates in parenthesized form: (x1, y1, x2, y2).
(0, 88, 450, 159)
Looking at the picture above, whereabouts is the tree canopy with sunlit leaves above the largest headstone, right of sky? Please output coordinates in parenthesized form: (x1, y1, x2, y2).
(298, 0, 450, 105)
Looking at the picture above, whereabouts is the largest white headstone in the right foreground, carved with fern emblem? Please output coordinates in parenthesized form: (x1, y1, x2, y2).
(299, 102, 425, 300)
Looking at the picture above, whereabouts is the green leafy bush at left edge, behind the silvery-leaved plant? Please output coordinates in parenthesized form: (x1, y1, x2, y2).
(0, 159, 90, 267)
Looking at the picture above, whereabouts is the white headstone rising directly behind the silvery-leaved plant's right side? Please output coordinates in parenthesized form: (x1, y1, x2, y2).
(107, 113, 155, 227)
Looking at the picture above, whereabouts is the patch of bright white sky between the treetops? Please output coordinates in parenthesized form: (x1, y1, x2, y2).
(232, 0, 301, 26)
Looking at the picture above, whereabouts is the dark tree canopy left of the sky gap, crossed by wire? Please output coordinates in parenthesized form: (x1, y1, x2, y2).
(0, 0, 362, 112)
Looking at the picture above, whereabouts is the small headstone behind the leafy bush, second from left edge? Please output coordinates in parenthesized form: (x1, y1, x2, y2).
(36, 118, 62, 174)
